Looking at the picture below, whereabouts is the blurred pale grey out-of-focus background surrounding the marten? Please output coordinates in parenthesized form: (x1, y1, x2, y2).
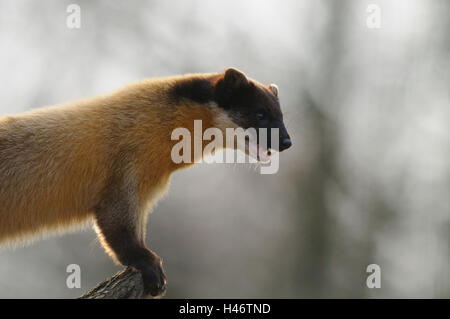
(0, 0, 450, 298)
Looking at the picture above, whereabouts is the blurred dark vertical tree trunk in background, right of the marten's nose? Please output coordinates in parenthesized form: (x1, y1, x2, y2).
(290, 1, 373, 298)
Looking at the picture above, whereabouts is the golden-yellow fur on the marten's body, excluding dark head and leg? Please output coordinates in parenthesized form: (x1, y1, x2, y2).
(0, 76, 233, 248)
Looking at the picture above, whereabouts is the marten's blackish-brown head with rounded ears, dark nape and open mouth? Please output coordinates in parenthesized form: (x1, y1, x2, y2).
(175, 68, 292, 160)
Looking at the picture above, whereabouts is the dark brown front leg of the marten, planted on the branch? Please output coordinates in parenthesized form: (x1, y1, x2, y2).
(95, 191, 167, 296)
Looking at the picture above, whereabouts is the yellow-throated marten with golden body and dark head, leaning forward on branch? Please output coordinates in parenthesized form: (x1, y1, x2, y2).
(0, 68, 291, 296)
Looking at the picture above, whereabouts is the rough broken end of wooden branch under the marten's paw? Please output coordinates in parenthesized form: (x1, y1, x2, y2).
(79, 267, 144, 299)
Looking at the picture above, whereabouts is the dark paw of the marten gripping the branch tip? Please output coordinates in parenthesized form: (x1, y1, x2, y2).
(140, 256, 167, 297)
